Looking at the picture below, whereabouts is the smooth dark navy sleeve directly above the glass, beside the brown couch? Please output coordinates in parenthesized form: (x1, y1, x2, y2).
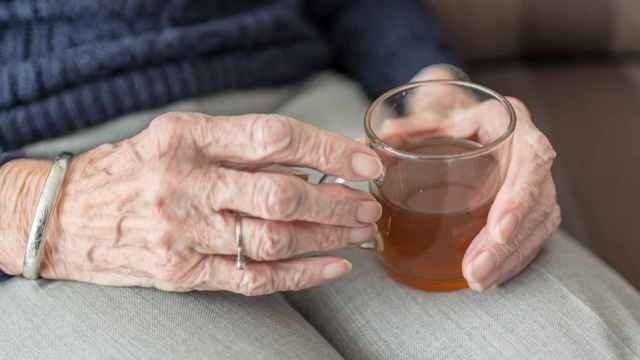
(307, 0, 460, 97)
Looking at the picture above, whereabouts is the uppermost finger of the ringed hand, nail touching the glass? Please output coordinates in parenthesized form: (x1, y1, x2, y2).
(152, 113, 382, 180)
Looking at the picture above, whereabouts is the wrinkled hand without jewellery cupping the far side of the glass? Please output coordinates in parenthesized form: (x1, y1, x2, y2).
(379, 66, 561, 291)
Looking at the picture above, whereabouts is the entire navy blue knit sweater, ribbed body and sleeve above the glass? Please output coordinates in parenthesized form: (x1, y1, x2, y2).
(0, 0, 455, 152)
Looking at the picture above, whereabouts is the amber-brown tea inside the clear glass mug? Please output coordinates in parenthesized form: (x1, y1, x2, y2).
(372, 138, 500, 291)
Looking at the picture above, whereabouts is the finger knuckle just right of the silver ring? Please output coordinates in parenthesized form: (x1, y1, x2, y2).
(254, 221, 293, 261)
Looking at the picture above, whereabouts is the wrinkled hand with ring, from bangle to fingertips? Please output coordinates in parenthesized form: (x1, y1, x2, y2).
(22, 113, 382, 295)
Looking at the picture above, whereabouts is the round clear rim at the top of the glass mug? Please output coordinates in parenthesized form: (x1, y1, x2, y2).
(364, 79, 517, 160)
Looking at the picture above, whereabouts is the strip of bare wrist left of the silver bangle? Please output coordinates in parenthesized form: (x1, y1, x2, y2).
(0, 160, 53, 275)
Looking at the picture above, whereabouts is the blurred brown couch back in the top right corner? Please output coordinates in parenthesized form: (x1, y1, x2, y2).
(425, 0, 640, 60)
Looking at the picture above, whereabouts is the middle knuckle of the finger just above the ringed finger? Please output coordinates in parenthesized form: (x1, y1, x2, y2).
(256, 176, 305, 221)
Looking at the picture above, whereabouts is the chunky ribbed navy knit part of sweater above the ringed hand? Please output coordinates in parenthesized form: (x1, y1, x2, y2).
(0, 0, 331, 150)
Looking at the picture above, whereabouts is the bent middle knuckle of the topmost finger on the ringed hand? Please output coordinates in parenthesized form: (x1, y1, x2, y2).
(249, 114, 294, 158)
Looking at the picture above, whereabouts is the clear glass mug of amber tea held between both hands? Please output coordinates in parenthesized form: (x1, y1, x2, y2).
(364, 80, 516, 291)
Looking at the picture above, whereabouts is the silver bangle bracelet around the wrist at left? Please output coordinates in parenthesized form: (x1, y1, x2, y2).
(22, 152, 73, 280)
